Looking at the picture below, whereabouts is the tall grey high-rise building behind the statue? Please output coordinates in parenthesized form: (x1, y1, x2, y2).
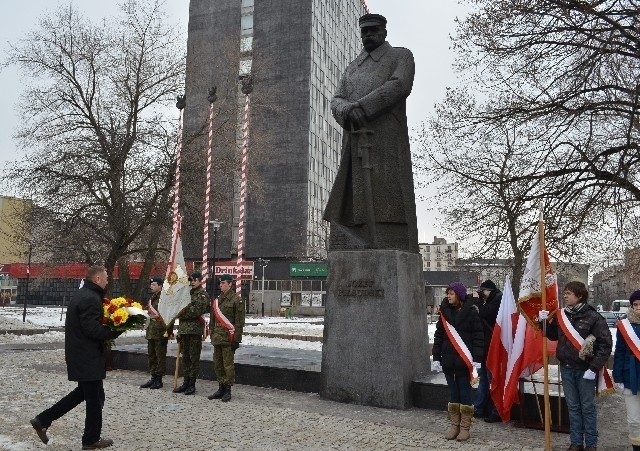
(183, 0, 365, 259)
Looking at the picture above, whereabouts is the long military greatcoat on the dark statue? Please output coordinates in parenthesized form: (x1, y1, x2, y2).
(324, 42, 418, 252)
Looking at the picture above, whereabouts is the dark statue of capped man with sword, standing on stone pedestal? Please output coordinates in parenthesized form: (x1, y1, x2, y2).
(324, 14, 418, 253)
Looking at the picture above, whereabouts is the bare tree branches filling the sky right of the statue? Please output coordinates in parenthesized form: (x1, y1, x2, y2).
(412, 0, 640, 282)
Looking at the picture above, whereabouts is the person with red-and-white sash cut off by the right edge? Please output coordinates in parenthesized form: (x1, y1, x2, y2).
(613, 290, 640, 451)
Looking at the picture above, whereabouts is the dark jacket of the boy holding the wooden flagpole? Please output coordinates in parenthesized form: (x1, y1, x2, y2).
(547, 305, 613, 373)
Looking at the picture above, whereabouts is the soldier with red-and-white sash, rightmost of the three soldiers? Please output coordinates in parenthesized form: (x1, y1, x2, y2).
(208, 274, 244, 402)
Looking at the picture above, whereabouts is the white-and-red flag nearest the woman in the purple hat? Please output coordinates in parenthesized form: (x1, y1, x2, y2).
(487, 278, 519, 421)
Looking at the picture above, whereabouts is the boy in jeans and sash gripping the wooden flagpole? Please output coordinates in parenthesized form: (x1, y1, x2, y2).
(538, 281, 613, 451)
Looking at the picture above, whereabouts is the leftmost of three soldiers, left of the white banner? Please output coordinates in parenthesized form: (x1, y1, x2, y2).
(140, 277, 169, 389)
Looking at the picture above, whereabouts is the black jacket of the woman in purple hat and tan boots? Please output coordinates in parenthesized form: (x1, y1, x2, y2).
(432, 297, 484, 375)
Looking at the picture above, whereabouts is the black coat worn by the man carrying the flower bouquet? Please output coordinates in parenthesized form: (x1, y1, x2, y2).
(64, 280, 120, 381)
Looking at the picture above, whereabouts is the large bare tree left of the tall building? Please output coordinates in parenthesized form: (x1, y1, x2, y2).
(6, 0, 185, 298)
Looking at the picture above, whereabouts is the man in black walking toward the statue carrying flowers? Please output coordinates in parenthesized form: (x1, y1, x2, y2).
(31, 266, 121, 449)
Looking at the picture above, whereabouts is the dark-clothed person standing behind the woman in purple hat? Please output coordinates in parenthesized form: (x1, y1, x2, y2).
(473, 279, 502, 423)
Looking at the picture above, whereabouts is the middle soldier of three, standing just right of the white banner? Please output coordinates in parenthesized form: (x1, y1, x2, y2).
(173, 272, 209, 395)
